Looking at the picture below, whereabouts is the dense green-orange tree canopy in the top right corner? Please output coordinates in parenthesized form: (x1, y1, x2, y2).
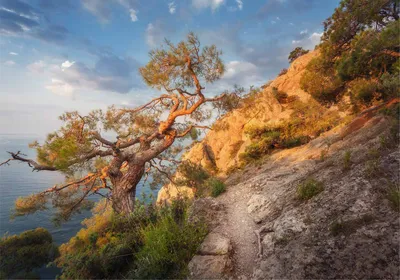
(300, 0, 400, 105)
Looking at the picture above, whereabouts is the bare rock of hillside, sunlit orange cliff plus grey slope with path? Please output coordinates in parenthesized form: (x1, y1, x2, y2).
(158, 52, 400, 279)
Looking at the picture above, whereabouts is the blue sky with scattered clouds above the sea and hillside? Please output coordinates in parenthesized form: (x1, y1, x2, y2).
(0, 0, 339, 136)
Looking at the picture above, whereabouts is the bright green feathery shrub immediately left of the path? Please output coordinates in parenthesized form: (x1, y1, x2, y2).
(132, 199, 207, 279)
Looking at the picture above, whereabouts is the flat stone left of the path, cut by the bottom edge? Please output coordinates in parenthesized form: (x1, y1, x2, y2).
(188, 255, 231, 279)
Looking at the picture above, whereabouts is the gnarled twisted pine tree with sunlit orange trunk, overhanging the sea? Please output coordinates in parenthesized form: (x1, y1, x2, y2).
(1, 33, 225, 219)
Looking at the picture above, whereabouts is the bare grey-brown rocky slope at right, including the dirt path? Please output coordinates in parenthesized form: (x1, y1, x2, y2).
(192, 100, 400, 279)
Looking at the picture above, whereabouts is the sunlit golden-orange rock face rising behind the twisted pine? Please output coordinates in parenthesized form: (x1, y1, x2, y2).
(181, 51, 318, 173)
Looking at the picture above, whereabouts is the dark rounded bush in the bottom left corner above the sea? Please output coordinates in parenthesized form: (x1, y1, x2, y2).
(0, 228, 58, 279)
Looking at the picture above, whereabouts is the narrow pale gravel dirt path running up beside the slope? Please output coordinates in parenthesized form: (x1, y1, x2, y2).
(217, 184, 258, 278)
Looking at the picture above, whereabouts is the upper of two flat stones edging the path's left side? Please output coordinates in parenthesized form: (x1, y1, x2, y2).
(198, 232, 232, 255)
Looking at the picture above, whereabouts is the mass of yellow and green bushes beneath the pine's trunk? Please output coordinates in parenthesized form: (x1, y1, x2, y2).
(56, 199, 206, 279)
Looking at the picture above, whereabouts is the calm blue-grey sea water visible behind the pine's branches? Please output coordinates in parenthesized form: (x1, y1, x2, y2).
(0, 134, 149, 279)
